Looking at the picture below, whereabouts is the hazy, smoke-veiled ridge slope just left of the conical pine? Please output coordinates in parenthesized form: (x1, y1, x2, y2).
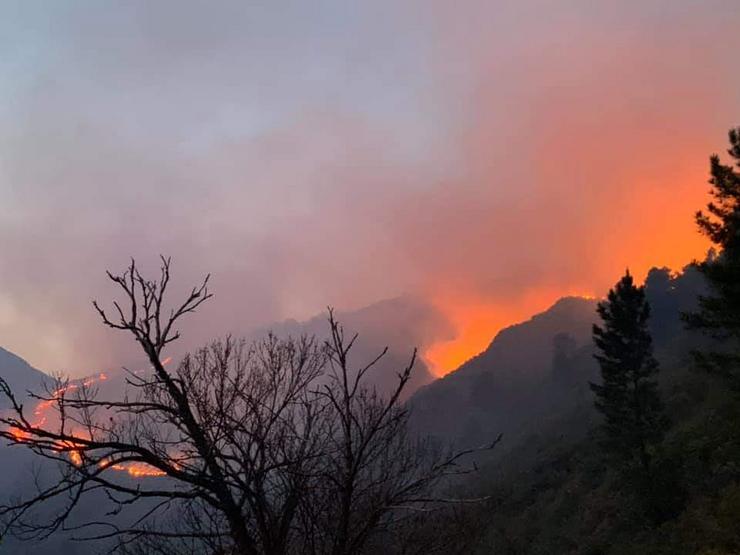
(409, 297, 596, 446)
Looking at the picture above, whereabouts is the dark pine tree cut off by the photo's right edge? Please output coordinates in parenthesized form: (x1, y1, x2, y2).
(684, 128, 740, 389)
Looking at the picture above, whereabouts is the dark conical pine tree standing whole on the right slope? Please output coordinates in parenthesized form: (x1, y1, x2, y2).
(591, 271, 667, 475)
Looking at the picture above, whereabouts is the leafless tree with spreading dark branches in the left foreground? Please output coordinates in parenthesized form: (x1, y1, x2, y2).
(0, 258, 498, 555)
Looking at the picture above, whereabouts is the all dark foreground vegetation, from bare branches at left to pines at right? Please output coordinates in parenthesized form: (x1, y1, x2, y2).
(0, 130, 740, 555)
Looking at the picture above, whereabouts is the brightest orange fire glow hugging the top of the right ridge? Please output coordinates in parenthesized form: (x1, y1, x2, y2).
(422, 156, 710, 376)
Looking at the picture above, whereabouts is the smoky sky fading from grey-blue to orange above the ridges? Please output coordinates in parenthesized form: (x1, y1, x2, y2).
(0, 0, 740, 375)
